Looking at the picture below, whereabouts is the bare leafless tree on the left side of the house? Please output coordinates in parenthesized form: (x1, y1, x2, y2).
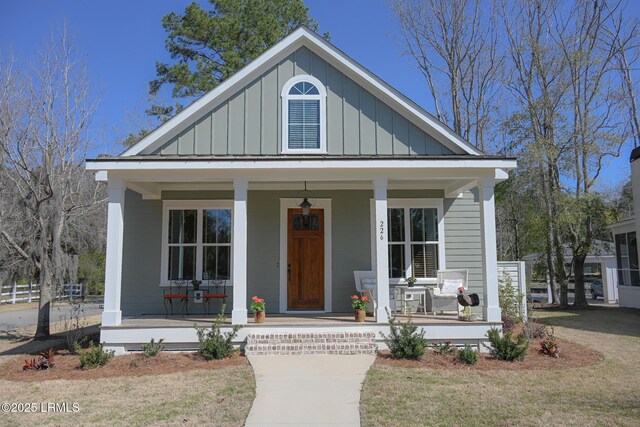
(0, 29, 100, 339)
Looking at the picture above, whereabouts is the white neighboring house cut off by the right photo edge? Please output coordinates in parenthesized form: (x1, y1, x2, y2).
(610, 148, 640, 308)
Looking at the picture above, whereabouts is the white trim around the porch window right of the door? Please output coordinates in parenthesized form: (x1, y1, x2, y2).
(370, 198, 447, 285)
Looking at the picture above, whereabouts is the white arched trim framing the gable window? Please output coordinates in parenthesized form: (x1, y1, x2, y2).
(280, 74, 327, 154)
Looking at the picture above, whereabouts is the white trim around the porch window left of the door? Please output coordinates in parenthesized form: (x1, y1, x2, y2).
(159, 200, 234, 287)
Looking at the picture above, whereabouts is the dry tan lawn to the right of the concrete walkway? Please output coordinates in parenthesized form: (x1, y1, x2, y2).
(360, 309, 640, 426)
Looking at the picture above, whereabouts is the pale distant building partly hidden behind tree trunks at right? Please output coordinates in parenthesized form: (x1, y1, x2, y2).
(522, 240, 618, 303)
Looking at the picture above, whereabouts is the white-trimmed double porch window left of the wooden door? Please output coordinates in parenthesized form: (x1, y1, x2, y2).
(161, 201, 233, 284)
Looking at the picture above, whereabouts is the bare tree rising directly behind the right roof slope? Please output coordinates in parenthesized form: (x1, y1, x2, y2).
(393, 0, 503, 150)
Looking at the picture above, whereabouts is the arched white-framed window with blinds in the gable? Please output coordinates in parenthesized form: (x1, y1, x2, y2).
(282, 76, 327, 153)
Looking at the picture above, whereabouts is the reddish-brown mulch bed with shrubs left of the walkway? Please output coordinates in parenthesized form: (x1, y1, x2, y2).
(0, 352, 249, 381)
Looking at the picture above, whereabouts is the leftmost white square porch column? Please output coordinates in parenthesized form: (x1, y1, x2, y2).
(102, 178, 126, 326)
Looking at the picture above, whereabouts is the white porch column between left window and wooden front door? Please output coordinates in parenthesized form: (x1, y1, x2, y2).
(231, 178, 249, 325)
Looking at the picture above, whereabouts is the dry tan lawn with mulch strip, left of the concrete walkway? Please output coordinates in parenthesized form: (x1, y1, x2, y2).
(0, 354, 255, 426)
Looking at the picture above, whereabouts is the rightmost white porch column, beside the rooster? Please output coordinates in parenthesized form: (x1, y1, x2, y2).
(478, 177, 501, 322)
